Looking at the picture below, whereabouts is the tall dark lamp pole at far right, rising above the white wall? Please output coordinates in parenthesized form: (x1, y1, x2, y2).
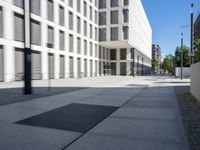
(190, 3, 194, 65)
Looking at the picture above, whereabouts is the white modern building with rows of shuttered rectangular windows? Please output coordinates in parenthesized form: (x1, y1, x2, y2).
(0, 0, 152, 82)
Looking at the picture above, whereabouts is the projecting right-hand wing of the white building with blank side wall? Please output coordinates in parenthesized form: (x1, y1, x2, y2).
(99, 0, 152, 75)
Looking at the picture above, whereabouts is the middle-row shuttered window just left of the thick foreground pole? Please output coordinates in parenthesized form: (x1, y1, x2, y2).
(14, 13, 24, 42)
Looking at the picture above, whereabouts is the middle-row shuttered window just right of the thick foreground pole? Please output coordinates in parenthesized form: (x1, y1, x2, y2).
(31, 20, 41, 45)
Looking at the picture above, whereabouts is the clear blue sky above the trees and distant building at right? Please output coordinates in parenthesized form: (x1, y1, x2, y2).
(142, 0, 200, 55)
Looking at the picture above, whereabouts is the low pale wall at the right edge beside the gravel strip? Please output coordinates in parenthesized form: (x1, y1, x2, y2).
(190, 62, 200, 100)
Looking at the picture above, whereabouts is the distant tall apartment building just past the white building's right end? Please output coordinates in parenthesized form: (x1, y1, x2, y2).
(152, 44, 162, 74)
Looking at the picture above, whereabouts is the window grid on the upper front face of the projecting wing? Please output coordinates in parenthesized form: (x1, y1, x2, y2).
(99, 0, 129, 42)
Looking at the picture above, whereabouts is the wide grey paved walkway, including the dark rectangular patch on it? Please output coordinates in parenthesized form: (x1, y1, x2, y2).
(0, 77, 189, 150)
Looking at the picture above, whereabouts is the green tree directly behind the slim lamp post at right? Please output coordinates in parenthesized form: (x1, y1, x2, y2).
(175, 45, 190, 67)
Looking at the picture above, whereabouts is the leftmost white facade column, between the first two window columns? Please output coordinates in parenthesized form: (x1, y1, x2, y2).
(3, 4, 15, 82)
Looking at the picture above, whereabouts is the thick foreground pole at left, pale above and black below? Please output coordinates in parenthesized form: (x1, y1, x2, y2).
(24, 0, 32, 95)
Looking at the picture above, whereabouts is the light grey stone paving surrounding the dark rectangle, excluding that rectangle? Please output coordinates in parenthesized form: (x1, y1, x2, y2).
(0, 77, 189, 150)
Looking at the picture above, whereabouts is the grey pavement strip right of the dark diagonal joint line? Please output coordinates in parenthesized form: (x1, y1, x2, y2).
(66, 79, 190, 150)
